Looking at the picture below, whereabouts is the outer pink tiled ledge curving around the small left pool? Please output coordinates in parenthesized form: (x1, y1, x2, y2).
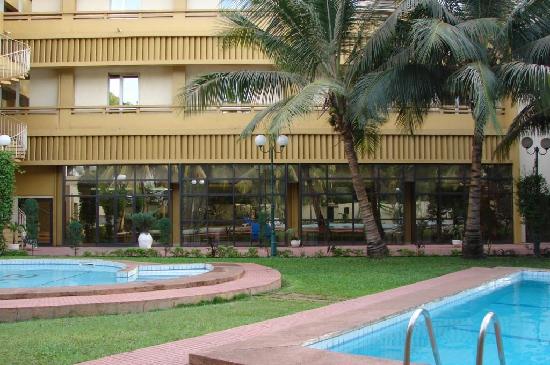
(0, 264, 281, 322)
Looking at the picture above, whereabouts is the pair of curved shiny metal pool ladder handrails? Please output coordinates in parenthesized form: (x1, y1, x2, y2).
(403, 308, 506, 365)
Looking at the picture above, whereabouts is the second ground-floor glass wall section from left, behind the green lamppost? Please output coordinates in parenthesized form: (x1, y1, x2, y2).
(180, 164, 294, 245)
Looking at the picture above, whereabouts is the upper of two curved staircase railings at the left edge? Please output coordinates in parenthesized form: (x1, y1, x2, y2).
(0, 34, 31, 84)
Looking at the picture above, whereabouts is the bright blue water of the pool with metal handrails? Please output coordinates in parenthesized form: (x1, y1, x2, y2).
(310, 272, 550, 365)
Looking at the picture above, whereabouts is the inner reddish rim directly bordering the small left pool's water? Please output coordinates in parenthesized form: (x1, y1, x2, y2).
(0, 259, 244, 302)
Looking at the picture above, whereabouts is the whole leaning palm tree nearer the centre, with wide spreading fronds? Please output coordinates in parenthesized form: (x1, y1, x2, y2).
(181, 0, 453, 256)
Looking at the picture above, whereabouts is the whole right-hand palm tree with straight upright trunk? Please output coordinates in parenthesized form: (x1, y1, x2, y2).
(413, 0, 550, 258)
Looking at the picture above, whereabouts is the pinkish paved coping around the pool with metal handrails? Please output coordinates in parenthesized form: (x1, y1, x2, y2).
(189, 267, 536, 365)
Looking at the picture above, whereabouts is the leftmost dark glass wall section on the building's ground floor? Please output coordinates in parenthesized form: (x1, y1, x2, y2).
(64, 165, 171, 245)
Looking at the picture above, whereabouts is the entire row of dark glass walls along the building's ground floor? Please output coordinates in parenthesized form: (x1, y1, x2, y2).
(64, 164, 513, 246)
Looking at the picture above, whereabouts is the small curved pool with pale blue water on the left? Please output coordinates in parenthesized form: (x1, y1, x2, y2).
(0, 259, 212, 289)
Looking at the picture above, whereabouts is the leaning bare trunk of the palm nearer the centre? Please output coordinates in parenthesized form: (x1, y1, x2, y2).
(341, 128, 388, 257)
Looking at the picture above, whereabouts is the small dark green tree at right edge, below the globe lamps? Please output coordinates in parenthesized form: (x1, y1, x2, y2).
(517, 174, 550, 256)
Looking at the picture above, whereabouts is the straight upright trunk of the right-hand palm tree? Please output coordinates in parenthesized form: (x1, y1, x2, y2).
(462, 135, 484, 259)
